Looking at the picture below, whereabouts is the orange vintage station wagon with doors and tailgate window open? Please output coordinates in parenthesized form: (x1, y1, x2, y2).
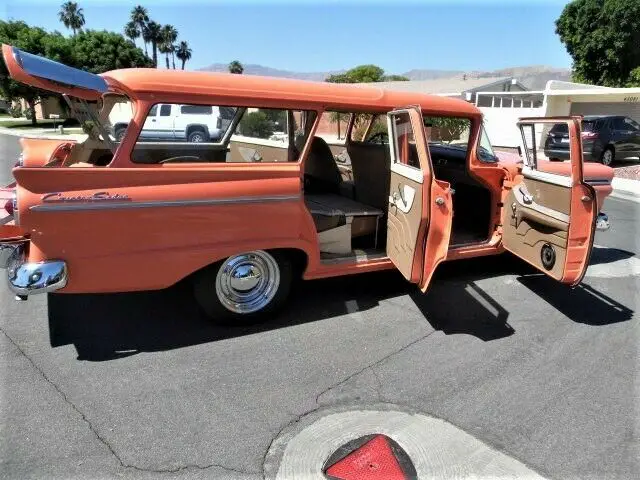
(0, 45, 613, 321)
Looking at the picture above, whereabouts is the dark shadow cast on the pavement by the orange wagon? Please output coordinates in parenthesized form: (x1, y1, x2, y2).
(48, 255, 632, 361)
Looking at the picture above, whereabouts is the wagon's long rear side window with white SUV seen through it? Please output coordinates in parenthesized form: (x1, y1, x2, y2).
(132, 104, 316, 163)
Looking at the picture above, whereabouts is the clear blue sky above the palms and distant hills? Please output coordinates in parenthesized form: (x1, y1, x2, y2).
(0, 0, 571, 73)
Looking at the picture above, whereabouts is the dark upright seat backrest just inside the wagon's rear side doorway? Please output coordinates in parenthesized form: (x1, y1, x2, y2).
(304, 136, 343, 195)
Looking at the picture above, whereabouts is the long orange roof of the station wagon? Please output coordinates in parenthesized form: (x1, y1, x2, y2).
(101, 68, 482, 117)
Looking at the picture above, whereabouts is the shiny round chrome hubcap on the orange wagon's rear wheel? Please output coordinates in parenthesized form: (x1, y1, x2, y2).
(216, 250, 280, 314)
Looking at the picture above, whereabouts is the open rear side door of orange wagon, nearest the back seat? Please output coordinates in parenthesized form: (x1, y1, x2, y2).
(387, 107, 453, 291)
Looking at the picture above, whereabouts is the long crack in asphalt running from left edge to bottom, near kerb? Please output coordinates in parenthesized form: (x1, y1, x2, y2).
(0, 328, 262, 475)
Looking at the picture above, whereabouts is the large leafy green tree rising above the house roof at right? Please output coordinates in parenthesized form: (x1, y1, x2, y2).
(555, 0, 640, 87)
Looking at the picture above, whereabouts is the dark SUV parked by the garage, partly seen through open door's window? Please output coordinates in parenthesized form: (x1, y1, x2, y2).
(544, 115, 640, 165)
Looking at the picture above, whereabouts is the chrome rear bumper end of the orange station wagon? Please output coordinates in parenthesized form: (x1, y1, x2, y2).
(0, 243, 67, 298)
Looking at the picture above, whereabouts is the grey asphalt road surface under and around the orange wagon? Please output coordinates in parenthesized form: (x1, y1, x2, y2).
(0, 132, 640, 479)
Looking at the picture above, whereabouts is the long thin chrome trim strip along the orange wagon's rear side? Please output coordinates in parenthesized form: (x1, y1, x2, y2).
(29, 195, 302, 212)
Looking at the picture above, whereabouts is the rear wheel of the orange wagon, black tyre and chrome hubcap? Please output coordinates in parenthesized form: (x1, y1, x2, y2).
(193, 250, 293, 324)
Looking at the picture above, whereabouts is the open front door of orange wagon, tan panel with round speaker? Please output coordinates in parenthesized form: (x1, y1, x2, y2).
(502, 117, 598, 286)
